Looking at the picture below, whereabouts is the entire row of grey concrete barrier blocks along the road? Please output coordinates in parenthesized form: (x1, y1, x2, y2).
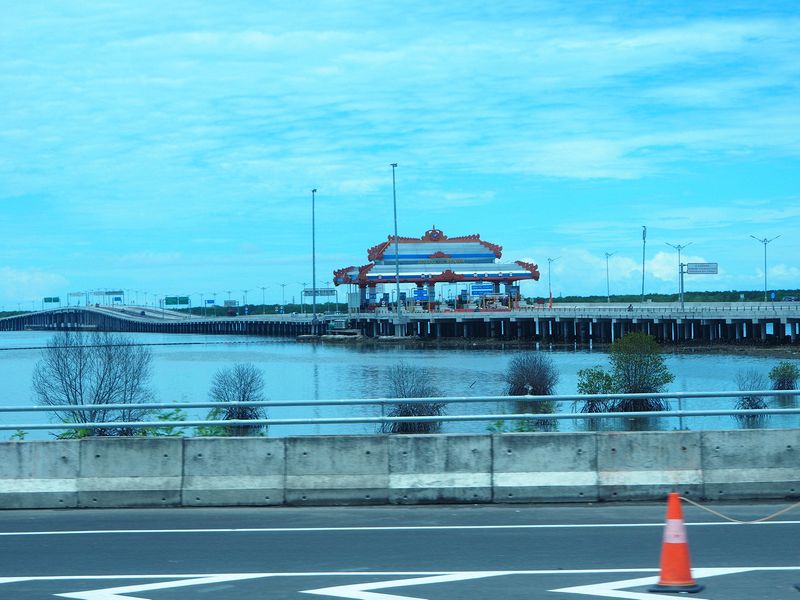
(0, 429, 800, 508)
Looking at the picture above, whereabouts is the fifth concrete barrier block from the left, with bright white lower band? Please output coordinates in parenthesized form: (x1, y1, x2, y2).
(389, 435, 492, 504)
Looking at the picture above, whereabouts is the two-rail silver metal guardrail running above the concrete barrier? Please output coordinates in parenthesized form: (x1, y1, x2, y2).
(0, 390, 800, 431)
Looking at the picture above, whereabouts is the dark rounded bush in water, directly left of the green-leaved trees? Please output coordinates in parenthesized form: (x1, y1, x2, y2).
(506, 352, 559, 431)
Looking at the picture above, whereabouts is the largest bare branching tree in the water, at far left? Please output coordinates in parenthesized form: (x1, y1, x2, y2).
(33, 332, 153, 437)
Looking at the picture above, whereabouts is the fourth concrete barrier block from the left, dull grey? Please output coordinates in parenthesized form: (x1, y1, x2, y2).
(286, 435, 389, 505)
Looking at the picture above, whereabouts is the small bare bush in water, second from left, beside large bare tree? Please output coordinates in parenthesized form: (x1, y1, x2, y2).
(206, 363, 267, 436)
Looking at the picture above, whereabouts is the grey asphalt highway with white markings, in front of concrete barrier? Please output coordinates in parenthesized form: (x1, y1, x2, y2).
(0, 503, 800, 600)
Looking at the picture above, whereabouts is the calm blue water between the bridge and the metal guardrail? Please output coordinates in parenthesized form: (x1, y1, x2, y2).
(0, 332, 800, 439)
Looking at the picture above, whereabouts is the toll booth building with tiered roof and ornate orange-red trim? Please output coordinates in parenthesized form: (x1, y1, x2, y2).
(333, 227, 539, 308)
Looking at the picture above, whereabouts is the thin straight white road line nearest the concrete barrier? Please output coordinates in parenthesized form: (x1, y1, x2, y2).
(0, 521, 800, 537)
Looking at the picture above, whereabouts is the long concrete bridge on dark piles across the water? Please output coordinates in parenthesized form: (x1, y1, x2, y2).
(0, 302, 800, 344)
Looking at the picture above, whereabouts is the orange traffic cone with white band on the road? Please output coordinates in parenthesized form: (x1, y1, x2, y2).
(648, 492, 703, 594)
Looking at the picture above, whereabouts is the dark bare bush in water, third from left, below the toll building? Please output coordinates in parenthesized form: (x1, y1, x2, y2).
(381, 365, 445, 433)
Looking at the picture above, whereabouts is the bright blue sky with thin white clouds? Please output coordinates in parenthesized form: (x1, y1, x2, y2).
(0, 0, 800, 308)
